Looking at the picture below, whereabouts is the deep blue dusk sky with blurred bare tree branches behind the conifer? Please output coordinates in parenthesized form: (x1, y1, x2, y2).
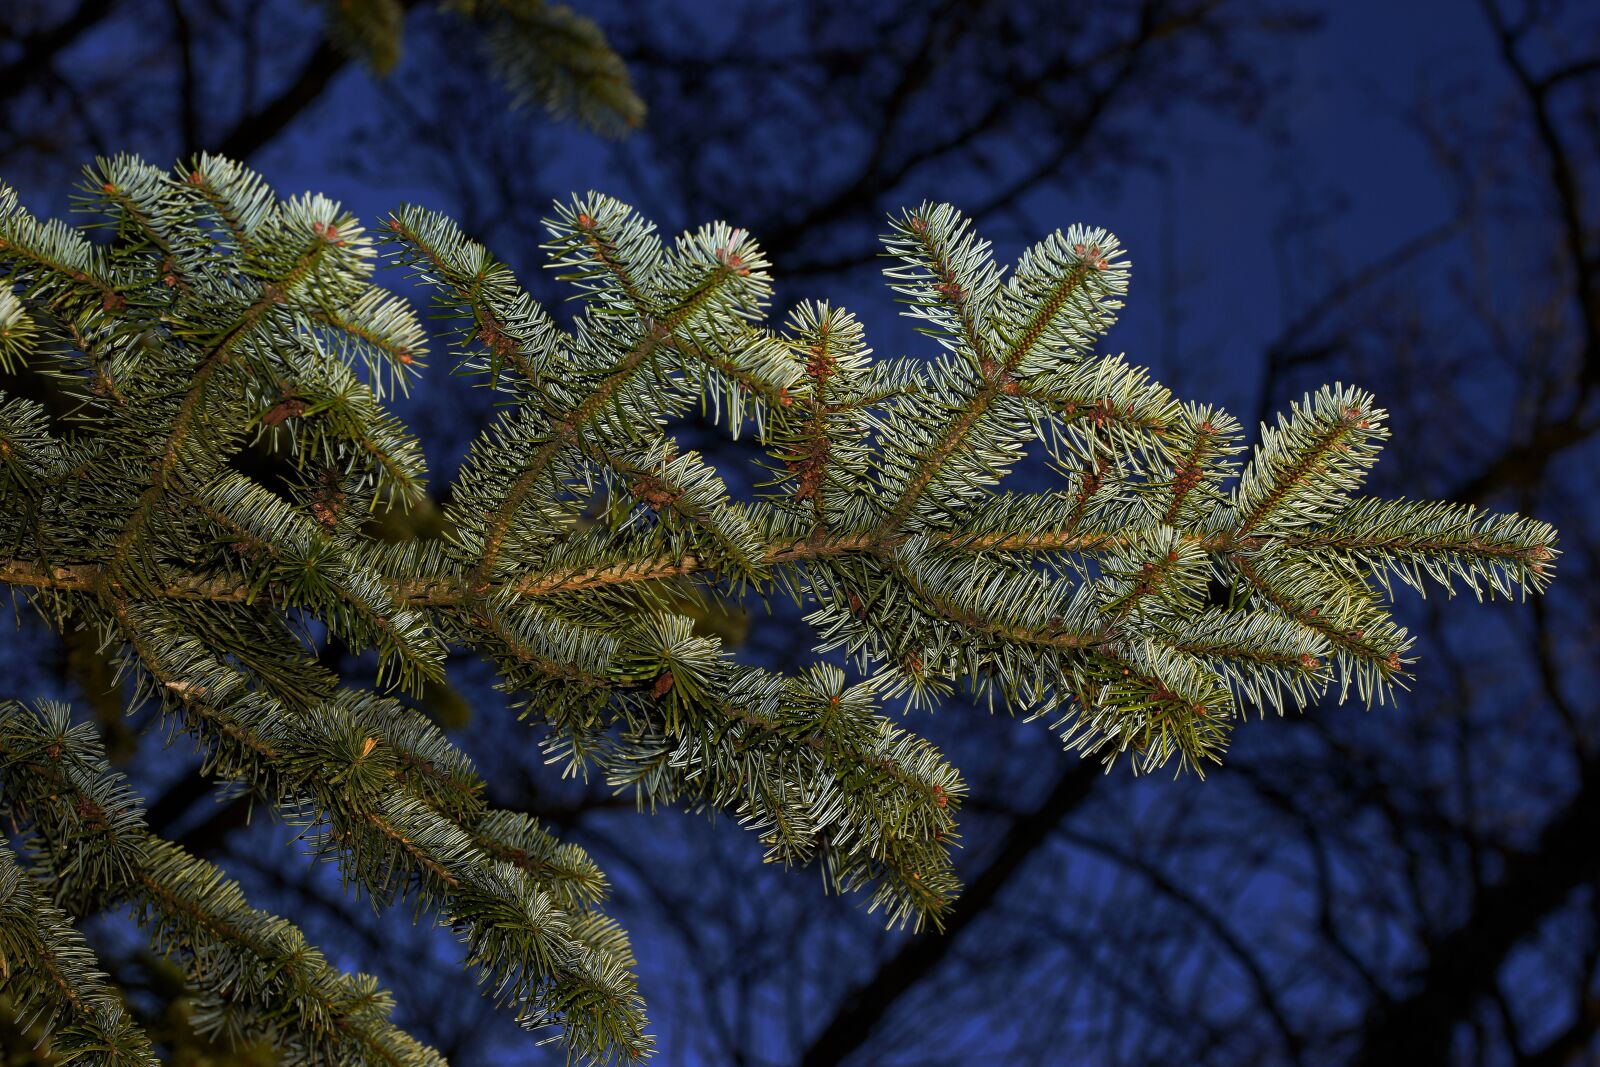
(0, 0, 1600, 1065)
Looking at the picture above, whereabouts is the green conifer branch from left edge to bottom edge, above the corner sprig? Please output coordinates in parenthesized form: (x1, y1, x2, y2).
(0, 702, 443, 1067)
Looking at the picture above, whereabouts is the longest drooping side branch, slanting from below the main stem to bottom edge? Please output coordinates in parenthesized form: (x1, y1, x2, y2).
(95, 608, 650, 1062)
